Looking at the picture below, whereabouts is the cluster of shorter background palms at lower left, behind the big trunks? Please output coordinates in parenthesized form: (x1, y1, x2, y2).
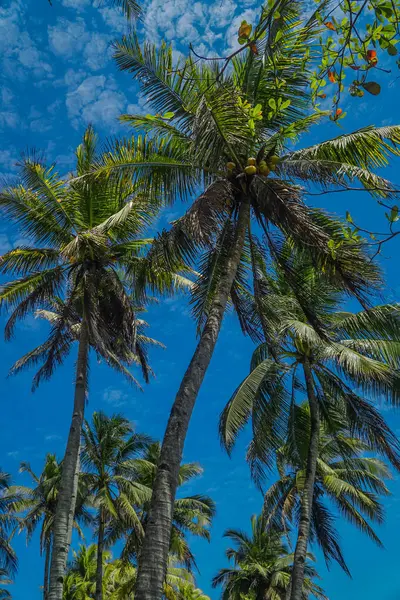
(1, 413, 215, 600)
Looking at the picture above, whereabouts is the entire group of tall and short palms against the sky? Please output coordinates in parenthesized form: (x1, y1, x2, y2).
(0, 0, 400, 600)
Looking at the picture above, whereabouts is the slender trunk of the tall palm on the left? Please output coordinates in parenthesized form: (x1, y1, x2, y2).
(48, 318, 89, 600)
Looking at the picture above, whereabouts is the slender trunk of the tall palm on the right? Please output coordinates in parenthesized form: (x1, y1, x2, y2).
(290, 359, 320, 600)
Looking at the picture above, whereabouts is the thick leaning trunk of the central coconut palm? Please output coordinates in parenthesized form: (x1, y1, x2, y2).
(135, 202, 250, 600)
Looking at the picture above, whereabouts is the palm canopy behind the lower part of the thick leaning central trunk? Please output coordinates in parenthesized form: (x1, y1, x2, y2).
(110, 442, 215, 569)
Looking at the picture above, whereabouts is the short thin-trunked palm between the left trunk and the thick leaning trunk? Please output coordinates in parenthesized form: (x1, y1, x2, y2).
(81, 412, 150, 600)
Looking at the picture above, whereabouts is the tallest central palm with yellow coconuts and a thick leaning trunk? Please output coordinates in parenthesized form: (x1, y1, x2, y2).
(104, 0, 400, 600)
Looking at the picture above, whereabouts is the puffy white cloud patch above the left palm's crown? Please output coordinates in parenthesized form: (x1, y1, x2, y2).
(66, 75, 126, 130)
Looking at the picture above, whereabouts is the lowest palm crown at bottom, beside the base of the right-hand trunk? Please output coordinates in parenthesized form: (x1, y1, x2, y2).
(213, 515, 326, 600)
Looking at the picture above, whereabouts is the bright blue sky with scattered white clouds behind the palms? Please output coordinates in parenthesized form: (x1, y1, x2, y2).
(0, 0, 400, 600)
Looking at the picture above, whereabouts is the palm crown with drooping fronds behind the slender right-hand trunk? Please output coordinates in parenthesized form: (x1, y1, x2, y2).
(263, 403, 390, 575)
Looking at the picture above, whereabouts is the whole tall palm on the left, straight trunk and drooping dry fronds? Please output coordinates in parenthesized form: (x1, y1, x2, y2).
(0, 127, 181, 600)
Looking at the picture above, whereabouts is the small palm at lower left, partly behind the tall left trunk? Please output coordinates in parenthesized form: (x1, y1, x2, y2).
(13, 454, 90, 600)
